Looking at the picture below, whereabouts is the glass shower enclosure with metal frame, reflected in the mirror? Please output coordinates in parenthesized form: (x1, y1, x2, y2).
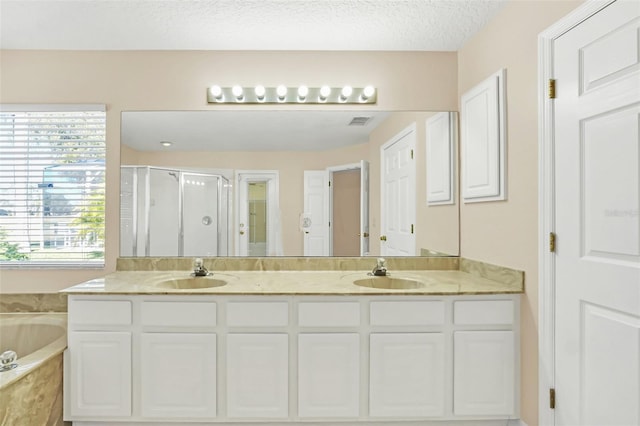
(120, 166, 229, 257)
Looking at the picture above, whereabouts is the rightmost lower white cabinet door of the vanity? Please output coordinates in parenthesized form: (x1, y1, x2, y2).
(453, 331, 516, 415)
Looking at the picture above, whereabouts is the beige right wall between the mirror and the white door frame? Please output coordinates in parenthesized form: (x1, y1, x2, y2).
(458, 0, 581, 426)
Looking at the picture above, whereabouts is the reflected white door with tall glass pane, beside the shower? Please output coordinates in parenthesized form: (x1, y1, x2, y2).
(236, 170, 282, 256)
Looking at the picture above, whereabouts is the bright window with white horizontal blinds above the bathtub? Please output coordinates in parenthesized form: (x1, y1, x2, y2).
(0, 104, 106, 267)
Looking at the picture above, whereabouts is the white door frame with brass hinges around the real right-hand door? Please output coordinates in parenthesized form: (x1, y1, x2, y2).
(538, 0, 615, 425)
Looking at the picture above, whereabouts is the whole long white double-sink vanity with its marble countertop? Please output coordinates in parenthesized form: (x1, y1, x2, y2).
(65, 262, 522, 425)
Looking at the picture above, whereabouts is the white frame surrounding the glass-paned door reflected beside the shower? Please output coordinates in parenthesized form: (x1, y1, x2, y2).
(233, 170, 281, 256)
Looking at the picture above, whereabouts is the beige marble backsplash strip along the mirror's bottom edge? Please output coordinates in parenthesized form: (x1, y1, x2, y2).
(116, 257, 460, 271)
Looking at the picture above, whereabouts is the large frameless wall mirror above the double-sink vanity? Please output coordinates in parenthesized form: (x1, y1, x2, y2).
(120, 110, 459, 257)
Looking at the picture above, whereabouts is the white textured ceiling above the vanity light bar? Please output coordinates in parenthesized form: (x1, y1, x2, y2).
(0, 0, 507, 51)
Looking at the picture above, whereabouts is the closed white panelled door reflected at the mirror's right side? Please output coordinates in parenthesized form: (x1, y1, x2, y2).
(380, 124, 416, 256)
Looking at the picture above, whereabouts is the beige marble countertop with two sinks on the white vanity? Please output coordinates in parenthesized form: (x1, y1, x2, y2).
(62, 270, 524, 295)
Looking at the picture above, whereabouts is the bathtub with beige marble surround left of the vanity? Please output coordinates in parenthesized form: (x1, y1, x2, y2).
(0, 313, 67, 426)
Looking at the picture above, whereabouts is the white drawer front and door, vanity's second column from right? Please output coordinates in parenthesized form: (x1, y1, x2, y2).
(369, 299, 447, 419)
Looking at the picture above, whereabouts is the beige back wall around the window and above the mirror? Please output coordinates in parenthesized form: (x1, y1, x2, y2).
(0, 50, 457, 293)
